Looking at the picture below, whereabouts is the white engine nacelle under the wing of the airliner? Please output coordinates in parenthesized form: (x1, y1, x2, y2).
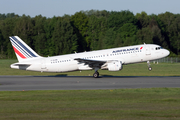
(107, 61, 123, 71)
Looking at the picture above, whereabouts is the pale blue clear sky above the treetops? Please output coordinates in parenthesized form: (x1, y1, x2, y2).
(0, 0, 180, 18)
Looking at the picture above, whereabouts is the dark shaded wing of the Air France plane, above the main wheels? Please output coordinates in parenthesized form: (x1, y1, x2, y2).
(74, 58, 107, 68)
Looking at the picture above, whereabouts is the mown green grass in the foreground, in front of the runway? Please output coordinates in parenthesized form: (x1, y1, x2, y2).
(0, 88, 180, 120)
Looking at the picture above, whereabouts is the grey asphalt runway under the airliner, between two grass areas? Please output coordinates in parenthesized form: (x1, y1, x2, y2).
(0, 76, 180, 91)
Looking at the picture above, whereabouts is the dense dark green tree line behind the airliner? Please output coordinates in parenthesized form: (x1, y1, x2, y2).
(0, 10, 180, 58)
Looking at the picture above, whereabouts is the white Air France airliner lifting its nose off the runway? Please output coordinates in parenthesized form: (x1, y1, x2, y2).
(9, 36, 169, 78)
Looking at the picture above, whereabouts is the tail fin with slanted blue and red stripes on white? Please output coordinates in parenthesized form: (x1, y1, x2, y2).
(9, 36, 40, 62)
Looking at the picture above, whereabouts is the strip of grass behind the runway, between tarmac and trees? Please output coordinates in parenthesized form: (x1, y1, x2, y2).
(0, 60, 180, 76)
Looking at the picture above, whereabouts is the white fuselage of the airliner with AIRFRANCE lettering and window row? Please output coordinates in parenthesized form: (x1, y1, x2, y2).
(11, 44, 169, 72)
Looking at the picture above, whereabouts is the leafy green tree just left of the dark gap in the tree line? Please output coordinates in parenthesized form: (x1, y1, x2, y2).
(52, 18, 78, 55)
